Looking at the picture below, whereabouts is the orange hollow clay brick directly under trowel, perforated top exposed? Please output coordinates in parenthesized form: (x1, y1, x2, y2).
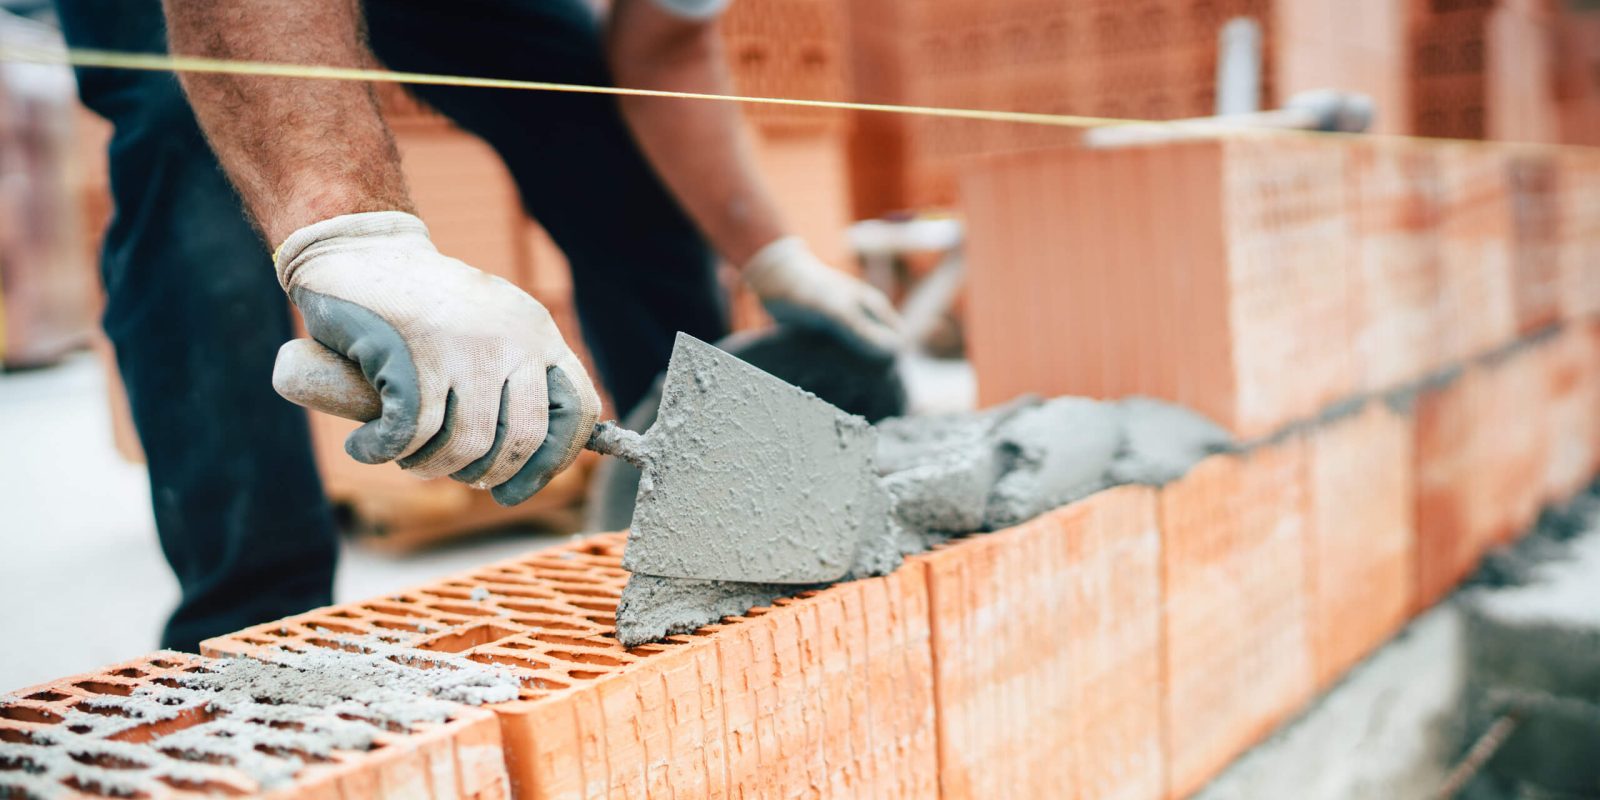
(203, 534, 938, 798)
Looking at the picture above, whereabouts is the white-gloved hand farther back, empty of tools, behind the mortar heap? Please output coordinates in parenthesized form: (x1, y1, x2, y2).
(744, 237, 901, 355)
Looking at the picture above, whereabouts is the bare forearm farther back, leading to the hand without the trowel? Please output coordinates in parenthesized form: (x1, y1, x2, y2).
(610, 0, 784, 266)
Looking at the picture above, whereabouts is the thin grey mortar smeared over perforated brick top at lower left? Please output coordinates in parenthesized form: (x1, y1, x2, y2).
(0, 637, 518, 797)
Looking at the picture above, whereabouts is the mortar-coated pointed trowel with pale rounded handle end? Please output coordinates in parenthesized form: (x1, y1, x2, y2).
(272, 333, 890, 584)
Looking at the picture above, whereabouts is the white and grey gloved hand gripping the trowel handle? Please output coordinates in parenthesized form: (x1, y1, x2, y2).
(274, 211, 600, 506)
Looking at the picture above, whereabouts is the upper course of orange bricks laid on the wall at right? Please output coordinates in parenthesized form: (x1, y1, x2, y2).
(965, 136, 1600, 438)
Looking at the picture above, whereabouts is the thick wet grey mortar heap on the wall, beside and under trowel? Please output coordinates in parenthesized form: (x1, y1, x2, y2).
(616, 390, 1234, 646)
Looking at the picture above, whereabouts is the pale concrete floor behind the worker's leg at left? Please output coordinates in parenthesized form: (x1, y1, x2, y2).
(0, 355, 572, 693)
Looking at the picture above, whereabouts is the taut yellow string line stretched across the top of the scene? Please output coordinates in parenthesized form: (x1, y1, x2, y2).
(0, 45, 1592, 150)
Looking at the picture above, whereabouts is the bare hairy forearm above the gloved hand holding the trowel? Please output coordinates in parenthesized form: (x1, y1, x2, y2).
(165, 0, 411, 246)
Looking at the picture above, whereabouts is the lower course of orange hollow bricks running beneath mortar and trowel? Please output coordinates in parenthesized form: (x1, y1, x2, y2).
(25, 294, 1600, 800)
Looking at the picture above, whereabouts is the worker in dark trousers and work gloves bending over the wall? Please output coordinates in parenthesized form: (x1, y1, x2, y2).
(58, 0, 896, 650)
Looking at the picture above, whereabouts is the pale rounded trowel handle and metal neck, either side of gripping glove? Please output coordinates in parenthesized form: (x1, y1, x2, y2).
(272, 339, 646, 469)
